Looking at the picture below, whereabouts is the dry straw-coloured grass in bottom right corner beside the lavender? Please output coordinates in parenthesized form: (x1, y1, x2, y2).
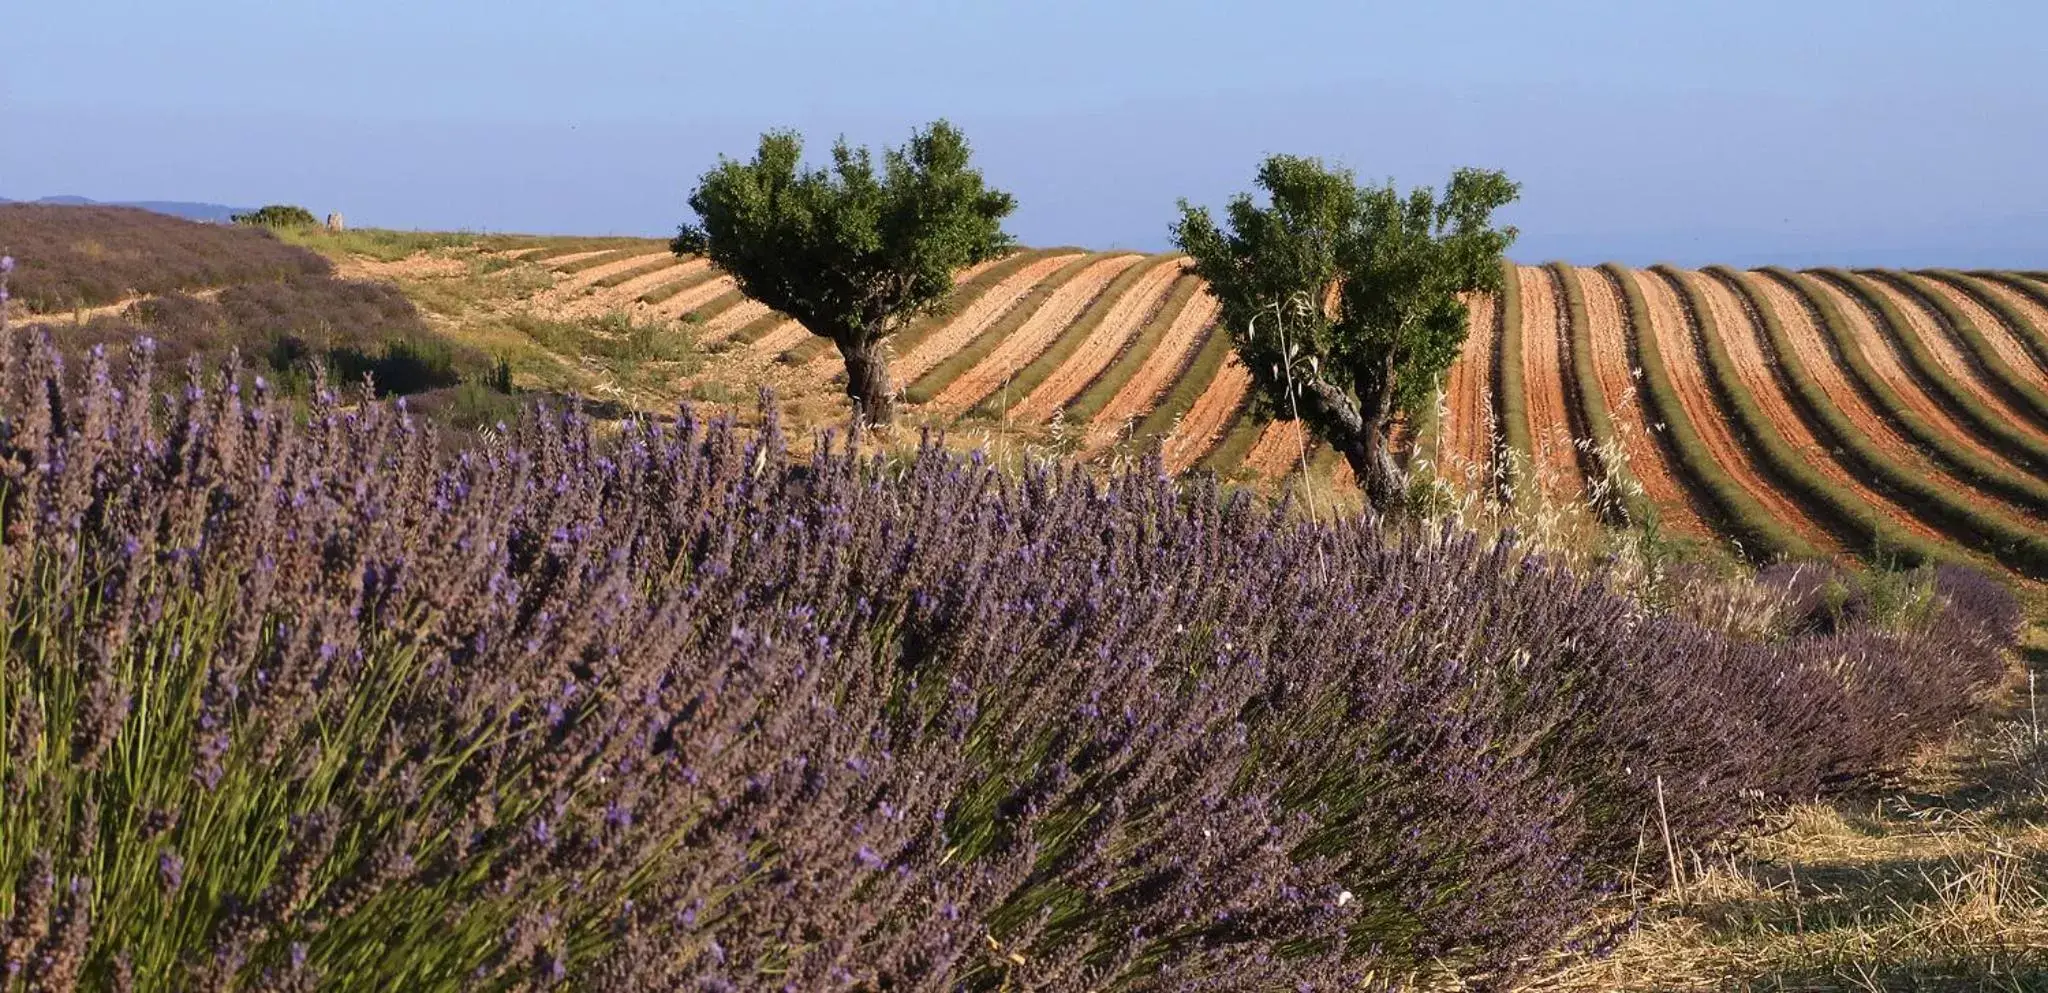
(1524, 629, 2048, 993)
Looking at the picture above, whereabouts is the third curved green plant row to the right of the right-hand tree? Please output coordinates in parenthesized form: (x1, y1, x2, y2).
(1599, 262, 1821, 561)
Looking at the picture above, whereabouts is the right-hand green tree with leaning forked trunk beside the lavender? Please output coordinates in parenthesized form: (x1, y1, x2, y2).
(1174, 156, 1520, 510)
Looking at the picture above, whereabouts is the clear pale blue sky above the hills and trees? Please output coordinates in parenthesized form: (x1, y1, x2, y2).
(0, 0, 2048, 268)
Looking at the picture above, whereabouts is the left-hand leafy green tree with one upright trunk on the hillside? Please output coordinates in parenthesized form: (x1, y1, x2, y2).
(670, 121, 1016, 424)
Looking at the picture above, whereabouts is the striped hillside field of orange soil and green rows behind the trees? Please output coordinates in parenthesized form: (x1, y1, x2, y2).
(28, 231, 2048, 579)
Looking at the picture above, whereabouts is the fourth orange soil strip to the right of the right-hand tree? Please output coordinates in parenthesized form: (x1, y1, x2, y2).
(1630, 270, 1843, 555)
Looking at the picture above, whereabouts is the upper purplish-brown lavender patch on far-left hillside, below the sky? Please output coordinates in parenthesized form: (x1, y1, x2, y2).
(0, 203, 334, 313)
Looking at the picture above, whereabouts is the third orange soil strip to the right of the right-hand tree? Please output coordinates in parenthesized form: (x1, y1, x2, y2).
(1573, 268, 1712, 536)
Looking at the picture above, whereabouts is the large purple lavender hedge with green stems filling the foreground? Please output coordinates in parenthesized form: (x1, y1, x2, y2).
(0, 321, 2017, 991)
